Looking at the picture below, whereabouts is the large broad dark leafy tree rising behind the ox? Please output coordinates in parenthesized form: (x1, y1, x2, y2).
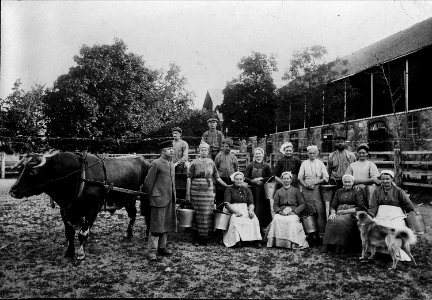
(45, 39, 192, 138)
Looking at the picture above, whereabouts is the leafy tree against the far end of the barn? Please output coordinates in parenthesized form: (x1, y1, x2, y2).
(277, 45, 355, 128)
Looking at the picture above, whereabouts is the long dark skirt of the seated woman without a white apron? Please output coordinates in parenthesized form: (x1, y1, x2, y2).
(323, 214, 361, 250)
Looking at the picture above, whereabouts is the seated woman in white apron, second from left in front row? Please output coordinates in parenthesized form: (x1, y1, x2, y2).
(267, 172, 309, 249)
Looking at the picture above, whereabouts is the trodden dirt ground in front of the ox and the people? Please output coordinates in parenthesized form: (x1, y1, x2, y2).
(0, 179, 432, 299)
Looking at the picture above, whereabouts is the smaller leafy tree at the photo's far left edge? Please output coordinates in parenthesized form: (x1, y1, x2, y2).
(0, 79, 45, 136)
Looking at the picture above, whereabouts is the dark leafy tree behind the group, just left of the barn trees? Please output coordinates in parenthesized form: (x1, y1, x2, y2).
(220, 52, 277, 136)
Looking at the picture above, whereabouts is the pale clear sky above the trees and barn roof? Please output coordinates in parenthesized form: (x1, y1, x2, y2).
(0, 0, 432, 108)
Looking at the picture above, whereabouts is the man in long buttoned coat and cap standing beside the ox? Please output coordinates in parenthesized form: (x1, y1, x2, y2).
(144, 141, 177, 261)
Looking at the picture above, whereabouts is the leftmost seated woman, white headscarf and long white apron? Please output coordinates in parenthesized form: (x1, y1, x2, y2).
(223, 172, 262, 247)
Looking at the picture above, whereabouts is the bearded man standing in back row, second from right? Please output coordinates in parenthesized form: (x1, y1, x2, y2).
(327, 136, 356, 189)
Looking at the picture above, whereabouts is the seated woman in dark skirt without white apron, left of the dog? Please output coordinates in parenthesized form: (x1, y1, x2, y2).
(321, 174, 366, 253)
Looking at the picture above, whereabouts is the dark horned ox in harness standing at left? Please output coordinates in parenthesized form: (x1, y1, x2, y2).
(9, 152, 150, 260)
